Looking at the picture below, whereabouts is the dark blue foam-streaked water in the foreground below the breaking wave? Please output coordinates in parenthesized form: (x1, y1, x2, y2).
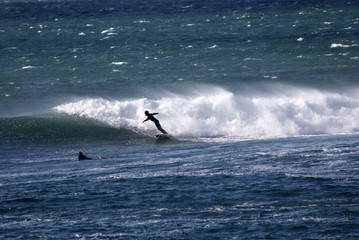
(1, 136, 359, 239)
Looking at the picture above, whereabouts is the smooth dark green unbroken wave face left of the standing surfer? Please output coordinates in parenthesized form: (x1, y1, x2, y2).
(0, 112, 143, 143)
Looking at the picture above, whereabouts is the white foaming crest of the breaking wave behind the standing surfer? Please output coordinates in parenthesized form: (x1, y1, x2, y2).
(55, 87, 359, 139)
